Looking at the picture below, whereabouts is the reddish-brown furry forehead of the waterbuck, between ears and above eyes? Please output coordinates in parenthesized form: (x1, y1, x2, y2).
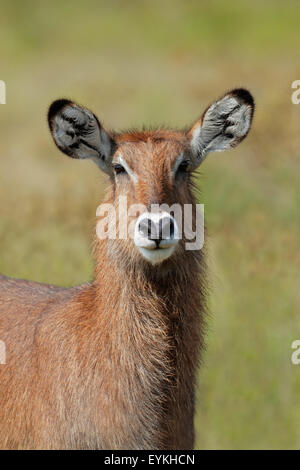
(115, 130, 187, 169)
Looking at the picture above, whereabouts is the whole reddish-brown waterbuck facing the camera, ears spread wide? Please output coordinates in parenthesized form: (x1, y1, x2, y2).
(0, 89, 254, 449)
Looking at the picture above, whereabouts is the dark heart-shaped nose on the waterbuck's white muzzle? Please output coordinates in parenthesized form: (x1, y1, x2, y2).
(139, 217, 174, 246)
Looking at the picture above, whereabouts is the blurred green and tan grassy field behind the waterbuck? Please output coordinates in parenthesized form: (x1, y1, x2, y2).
(0, 0, 300, 449)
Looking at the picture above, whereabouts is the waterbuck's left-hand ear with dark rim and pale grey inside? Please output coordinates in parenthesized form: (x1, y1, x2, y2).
(48, 99, 115, 173)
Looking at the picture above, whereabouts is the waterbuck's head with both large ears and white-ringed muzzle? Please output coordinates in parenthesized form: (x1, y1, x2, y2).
(48, 89, 254, 265)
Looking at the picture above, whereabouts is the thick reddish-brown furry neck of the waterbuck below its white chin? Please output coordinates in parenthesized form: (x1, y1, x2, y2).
(89, 240, 205, 449)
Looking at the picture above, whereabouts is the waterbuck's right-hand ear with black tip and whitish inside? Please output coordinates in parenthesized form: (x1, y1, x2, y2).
(188, 88, 254, 166)
